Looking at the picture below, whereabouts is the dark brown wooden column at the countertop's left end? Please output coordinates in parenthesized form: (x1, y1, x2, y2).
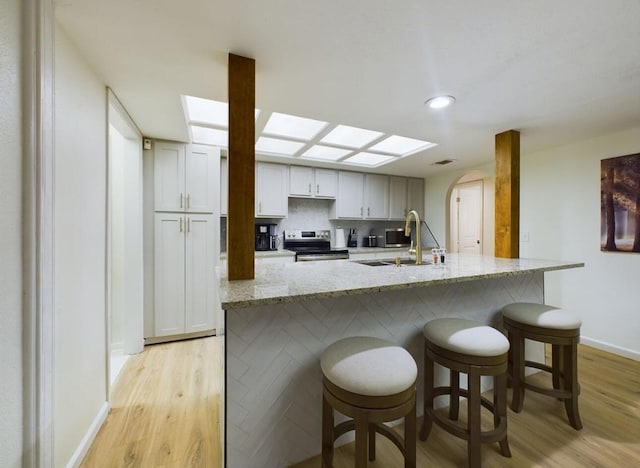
(227, 54, 256, 280)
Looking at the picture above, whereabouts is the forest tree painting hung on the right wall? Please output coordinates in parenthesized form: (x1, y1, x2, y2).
(600, 153, 640, 253)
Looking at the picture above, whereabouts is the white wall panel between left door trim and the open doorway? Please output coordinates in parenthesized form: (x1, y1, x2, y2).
(54, 22, 107, 466)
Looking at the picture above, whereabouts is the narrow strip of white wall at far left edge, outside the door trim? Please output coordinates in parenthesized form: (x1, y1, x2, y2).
(0, 0, 23, 468)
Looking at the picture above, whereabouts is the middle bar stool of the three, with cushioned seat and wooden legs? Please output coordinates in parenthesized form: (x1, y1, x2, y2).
(420, 318, 511, 467)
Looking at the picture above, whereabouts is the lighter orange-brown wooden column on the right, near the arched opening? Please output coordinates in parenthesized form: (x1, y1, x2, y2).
(495, 130, 520, 258)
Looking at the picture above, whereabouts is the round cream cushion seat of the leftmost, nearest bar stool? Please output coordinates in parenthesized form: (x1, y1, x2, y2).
(320, 336, 418, 396)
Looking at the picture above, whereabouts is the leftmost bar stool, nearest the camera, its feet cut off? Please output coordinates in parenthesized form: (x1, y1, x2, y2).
(320, 336, 418, 468)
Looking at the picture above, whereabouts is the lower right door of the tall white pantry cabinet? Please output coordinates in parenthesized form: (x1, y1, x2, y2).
(184, 215, 216, 333)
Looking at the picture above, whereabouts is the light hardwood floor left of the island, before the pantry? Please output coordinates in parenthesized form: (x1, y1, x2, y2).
(81, 337, 222, 468)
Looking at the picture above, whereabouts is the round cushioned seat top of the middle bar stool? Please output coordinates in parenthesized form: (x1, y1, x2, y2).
(423, 318, 509, 356)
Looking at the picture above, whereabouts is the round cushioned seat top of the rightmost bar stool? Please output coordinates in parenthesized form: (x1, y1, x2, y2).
(502, 302, 582, 330)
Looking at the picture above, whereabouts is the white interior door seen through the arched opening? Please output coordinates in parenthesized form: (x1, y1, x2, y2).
(454, 180, 482, 255)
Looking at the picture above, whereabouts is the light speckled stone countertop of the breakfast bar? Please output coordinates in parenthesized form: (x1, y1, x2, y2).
(217, 254, 584, 310)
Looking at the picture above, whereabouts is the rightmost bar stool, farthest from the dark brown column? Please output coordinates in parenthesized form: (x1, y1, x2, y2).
(502, 302, 582, 430)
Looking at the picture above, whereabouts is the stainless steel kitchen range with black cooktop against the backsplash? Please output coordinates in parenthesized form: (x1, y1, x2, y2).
(283, 229, 349, 262)
